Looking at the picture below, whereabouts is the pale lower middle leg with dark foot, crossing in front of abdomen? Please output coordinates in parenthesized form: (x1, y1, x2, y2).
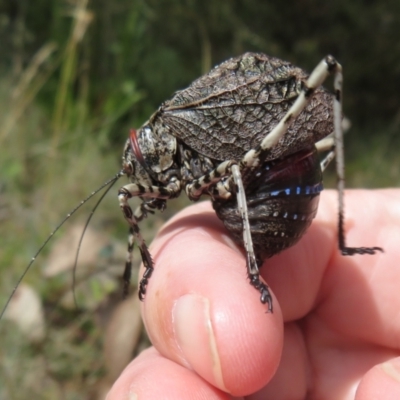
(231, 164, 272, 313)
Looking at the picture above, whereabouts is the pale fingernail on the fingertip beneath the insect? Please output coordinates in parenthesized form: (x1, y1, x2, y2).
(173, 294, 226, 391)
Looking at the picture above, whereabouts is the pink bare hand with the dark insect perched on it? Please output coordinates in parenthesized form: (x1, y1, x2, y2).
(107, 189, 400, 400)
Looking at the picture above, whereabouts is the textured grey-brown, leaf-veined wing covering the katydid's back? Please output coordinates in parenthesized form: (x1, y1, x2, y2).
(150, 53, 333, 161)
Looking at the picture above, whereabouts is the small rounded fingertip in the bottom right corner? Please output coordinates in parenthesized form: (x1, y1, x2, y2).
(355, 358, 400, 400)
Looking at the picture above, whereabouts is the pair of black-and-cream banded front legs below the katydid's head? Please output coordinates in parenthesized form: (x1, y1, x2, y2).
(118, 180, 180, 300)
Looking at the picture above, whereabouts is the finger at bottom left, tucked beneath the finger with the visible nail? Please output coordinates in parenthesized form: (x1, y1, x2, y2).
(107, 348, 230, 400)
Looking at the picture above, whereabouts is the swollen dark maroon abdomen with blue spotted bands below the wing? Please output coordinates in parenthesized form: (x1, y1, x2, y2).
(213, 149, 322, 259)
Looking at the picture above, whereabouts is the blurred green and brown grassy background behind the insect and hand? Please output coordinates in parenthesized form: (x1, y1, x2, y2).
(0, 0, 400, 400)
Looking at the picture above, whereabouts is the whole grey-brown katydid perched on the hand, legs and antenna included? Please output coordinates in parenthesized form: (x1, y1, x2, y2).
(3, 53, 382, 318)
